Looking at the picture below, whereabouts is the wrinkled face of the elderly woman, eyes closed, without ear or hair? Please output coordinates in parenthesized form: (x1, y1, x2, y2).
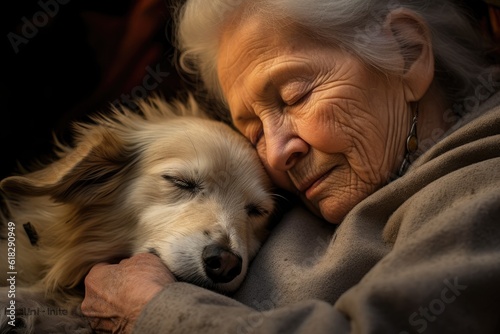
(218, 17, 410, 223)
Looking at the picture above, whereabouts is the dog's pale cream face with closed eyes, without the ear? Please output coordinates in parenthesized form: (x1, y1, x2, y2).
(129, 118, 274, 291)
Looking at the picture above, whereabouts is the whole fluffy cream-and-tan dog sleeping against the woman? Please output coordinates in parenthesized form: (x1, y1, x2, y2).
(0, 97, 274, 333)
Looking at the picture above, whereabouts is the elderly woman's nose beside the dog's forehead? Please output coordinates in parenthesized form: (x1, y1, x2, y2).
(264, 120, 309, 172)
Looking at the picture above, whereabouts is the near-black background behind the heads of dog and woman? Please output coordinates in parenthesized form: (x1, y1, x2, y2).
(0, 0, 500, 179)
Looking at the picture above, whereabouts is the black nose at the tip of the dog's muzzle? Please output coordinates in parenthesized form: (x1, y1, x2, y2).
(202, 245, 241, 283)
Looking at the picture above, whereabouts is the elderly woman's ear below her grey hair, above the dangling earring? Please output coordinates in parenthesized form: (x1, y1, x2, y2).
(385, 8, 434, 102)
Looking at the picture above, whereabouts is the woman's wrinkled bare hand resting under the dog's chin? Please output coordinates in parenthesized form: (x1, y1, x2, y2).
(82, 254, 175, 333)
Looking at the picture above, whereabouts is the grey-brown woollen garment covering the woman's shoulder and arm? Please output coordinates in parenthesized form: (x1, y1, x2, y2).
(136, 90, 500, 334)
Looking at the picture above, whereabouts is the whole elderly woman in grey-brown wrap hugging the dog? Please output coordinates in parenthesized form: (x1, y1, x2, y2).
(82, 0, 500, 333)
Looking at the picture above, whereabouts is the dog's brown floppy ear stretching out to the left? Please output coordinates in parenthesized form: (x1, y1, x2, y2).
(0, 128, 135, 204)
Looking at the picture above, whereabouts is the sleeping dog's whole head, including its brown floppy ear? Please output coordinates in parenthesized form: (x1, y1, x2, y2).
(1, 95, 275, 291)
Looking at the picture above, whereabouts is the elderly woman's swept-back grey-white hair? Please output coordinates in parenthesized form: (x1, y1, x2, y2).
(177, 0, 496, 116)
